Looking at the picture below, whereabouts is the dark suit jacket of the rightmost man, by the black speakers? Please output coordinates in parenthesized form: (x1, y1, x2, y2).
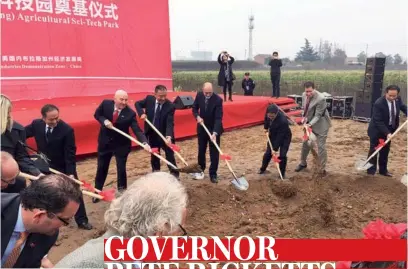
(367, 96, 407, 138)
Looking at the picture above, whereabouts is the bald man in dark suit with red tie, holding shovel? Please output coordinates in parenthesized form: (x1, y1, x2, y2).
(92, 90, 151, 203)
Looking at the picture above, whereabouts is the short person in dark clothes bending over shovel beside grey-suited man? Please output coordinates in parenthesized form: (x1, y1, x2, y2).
(258, 104, 292, 178)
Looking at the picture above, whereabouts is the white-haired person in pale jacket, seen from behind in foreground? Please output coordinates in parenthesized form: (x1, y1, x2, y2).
(55, 172, 187, 268)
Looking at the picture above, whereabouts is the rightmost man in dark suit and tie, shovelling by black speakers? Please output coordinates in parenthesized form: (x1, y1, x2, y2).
(367, 85, 407, 177)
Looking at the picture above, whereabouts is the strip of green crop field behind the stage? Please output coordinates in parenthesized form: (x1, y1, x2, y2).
(173, 70, 407, 97)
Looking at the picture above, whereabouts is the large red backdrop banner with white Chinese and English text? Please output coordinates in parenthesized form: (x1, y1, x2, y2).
(1, 0, 172, 100)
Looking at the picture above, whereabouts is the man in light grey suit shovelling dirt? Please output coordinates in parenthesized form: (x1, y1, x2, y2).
(295, 81, 331, 175)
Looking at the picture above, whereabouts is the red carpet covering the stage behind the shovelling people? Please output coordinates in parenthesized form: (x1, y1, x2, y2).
(12, 92, 298, 155)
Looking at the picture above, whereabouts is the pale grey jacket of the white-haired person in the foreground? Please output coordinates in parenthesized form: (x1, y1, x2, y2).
(55, 231, 142, 268)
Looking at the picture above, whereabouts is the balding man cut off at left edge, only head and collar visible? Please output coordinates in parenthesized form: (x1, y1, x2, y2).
(1, 151, 26, 193)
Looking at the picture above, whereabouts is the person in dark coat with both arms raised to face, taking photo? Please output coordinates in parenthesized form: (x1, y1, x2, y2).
(218, 51, 235, 102)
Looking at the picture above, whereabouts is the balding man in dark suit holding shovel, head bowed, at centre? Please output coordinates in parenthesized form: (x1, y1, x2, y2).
(192, 82, 224, 183)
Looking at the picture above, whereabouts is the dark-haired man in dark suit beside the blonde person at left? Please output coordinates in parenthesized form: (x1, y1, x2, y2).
(25, 104, 92, 230)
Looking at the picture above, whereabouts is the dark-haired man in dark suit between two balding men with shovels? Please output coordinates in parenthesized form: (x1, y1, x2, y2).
(135, 85, 179, 178)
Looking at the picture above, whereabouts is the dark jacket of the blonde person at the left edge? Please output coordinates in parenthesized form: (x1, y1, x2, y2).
(0, 121, 41, 176)
